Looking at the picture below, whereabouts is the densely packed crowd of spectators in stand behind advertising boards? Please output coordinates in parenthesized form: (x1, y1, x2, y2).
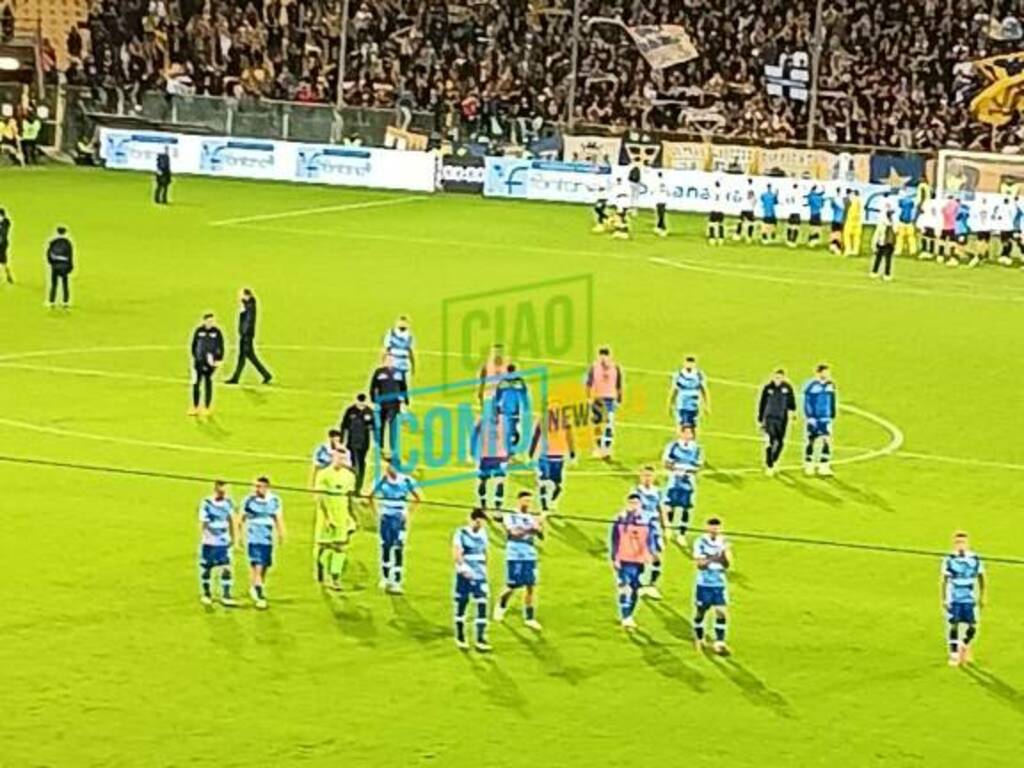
(67, 0, 1024, 148)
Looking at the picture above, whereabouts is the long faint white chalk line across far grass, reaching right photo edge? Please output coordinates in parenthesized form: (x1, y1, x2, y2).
(220, 223, 1024, 303)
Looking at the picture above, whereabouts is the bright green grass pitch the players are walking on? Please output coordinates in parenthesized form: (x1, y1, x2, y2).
(0, 169, 1024, 768)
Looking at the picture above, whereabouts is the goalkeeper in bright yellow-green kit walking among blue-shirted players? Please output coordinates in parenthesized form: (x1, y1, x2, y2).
(313, 451, 358, 592)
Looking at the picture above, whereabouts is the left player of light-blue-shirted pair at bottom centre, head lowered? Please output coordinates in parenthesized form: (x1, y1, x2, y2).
(452, 509, 490, 652)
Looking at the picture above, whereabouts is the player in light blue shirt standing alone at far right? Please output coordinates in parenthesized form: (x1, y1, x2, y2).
(941, 530, 985, 667)
